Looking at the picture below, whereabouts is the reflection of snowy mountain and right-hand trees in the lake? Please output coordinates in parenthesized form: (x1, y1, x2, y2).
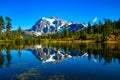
(29, 43, 120, 65)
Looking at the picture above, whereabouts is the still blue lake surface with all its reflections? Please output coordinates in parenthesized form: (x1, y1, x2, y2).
(0, 43, 120, 80)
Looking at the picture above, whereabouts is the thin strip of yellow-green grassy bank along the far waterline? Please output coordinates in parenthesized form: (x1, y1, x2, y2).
(0, 39, 120, 44)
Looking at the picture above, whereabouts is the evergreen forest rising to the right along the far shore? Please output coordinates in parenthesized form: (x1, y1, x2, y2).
(39, 19, 120, 42)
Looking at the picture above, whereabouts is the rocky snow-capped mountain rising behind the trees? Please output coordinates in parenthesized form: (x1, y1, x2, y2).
(29, 17, 87, 36)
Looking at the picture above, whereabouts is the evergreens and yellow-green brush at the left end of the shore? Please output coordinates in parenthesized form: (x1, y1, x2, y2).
(0, 16, 26, 44)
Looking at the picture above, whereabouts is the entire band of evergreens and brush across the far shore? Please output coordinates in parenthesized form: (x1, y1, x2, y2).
(0, 16, 120, 44)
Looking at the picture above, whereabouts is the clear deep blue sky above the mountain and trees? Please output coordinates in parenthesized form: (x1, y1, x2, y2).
(0, 0, 120, 29)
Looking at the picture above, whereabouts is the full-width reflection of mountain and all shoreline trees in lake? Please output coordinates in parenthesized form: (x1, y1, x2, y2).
(0, 43, 120, 67)
